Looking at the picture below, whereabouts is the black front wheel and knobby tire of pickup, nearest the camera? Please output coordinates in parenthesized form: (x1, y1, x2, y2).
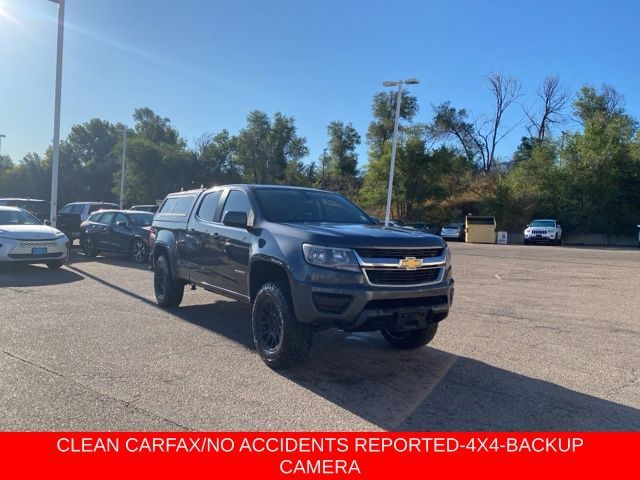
(251, 282, 313, 369)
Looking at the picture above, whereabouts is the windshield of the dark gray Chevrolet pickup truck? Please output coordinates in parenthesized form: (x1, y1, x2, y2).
(255, 188, 375, 224)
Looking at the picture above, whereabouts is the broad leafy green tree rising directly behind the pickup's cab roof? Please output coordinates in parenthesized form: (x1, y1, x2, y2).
(236, 110, 309, 183)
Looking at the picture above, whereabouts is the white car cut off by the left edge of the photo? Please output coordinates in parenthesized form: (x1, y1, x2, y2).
(0, 207, 69, 268)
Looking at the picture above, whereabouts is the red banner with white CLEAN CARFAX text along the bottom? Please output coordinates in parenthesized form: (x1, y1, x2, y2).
(0, 432, 640, 480)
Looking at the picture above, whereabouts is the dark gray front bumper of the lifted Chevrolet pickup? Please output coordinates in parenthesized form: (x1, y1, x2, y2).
(291, 266, 454, 331)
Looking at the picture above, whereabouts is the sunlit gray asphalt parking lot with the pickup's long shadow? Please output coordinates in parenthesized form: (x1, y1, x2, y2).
(0, 244, 640, 431)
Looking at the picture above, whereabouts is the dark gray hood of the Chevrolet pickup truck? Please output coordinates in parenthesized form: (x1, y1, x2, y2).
(276, 223, 445, 248)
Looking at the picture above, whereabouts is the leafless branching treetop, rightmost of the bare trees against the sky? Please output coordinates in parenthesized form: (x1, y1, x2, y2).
(524, 75, 571, 142)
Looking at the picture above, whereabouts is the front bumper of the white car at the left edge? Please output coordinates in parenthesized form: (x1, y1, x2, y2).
(0, 237, 69, 264)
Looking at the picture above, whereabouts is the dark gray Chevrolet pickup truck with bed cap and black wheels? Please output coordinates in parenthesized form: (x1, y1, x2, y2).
(149, 185, 453, 368)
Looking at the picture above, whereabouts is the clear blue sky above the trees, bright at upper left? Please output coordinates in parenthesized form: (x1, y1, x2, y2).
(0, 0, 640, 164)
